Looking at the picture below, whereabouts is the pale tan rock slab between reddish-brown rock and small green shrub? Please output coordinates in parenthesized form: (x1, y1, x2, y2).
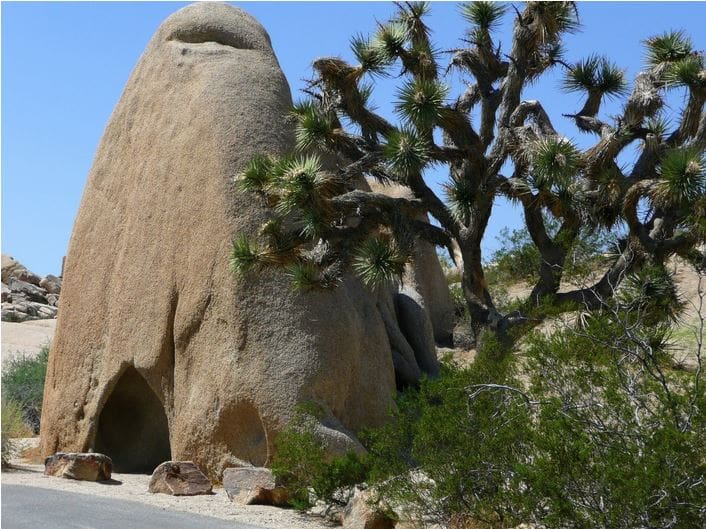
(223, 467, 289, 506)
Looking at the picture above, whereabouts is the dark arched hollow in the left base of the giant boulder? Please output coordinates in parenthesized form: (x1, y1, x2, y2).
(95, 367, 171, 473)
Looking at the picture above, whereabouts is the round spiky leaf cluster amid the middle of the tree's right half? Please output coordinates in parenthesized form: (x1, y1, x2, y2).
(529, 137, 582, 190)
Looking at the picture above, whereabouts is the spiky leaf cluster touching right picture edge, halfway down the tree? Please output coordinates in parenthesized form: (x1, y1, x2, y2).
(652, 149, 706, 207)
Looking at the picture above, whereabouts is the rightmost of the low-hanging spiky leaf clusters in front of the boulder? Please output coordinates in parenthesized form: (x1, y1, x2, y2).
(353, 236, 407, 286)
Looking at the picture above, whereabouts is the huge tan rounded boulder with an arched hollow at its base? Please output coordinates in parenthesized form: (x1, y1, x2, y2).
(41, 2, 440, 479)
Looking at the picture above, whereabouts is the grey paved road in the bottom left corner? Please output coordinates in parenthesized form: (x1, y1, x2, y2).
(0, 485, 262, 529)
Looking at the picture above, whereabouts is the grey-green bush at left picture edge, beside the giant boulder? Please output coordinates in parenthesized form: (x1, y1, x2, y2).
(2, 345, 49, 434)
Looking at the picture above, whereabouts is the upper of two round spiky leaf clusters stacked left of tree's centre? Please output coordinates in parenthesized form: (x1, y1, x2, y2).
(395, 79, 448, 130)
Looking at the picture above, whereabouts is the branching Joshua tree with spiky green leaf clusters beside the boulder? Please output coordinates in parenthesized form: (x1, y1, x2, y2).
(232, 2, 706, 340)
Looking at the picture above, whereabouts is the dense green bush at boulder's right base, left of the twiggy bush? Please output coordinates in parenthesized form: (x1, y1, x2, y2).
(364, 342, 531, 527)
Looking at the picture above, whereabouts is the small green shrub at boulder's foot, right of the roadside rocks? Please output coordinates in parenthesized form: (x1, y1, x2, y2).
(272, 405, 367, 509)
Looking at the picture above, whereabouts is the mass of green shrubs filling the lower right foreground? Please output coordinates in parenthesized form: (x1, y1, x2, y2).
(279, 289, 706, 529)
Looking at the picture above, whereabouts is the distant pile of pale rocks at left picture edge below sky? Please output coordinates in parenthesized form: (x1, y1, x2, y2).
(2, 254, 61, 323)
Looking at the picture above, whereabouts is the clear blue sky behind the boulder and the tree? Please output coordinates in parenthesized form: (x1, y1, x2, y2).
(1, 2, 706, 275)
